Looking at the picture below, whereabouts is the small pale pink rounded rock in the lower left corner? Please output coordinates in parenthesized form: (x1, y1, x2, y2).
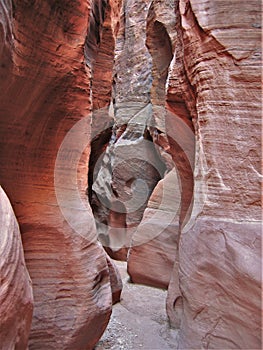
(0, 187, 33, 349)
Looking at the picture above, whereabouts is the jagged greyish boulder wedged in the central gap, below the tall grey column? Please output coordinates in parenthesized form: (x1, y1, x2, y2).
(92, 107, 165, 260)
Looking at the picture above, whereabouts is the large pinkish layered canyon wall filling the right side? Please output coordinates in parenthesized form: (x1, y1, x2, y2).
(168, 0, 261, 349)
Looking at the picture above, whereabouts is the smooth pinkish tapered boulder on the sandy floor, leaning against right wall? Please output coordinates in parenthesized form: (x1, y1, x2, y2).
(128, 168, 181, 288)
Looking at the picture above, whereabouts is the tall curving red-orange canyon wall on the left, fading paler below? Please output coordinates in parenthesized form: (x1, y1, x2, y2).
(0, 1, 120, 349)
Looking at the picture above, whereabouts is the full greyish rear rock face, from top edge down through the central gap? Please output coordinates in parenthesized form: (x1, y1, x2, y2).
(89, 1, 163, 260)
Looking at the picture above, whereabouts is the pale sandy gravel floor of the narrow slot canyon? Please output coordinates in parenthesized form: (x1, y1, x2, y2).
(94, 261, 178, 350)
